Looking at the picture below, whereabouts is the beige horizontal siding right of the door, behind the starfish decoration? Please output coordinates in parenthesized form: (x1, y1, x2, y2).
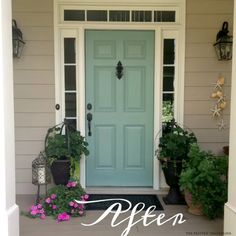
(184, 0, 233, 153)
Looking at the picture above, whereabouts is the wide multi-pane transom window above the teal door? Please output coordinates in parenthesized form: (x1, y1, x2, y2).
(63, 9, 177, 23)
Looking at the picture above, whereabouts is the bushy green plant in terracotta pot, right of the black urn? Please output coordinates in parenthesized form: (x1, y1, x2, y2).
(180, 144, 228, 219)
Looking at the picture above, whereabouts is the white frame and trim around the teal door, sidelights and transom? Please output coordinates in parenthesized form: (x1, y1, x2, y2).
(54, 0, 185, 189)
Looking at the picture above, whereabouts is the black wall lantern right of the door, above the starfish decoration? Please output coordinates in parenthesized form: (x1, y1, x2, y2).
(214, 21, 233, 61)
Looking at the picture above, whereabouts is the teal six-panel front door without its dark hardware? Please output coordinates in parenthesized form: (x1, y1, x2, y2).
(86, 30, 154, 186)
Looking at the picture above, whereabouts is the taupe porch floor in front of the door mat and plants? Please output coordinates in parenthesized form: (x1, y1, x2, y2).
(17, 195, 223, 236)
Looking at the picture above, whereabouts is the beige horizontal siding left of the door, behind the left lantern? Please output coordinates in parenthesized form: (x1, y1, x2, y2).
(13, 0, 55, 194)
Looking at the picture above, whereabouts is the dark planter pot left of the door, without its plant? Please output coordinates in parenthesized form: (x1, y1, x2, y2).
(51, 160, 70, 185)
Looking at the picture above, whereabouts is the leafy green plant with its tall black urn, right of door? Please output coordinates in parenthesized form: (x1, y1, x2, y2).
(157, 119, 197, 204)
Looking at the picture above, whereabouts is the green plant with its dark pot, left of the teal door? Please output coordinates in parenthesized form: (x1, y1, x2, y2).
(45, 120, 89, 185)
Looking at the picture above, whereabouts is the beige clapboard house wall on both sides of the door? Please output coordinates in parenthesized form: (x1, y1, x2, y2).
(13, 0, 233, 194)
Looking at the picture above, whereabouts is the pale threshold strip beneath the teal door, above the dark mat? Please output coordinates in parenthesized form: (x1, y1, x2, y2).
(85, 187, 168, 195)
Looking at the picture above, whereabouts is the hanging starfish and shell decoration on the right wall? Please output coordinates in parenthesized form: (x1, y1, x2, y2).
(211, 76, 227, 130)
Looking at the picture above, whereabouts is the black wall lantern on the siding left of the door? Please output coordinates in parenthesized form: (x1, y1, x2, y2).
(12, 20, 25, 58)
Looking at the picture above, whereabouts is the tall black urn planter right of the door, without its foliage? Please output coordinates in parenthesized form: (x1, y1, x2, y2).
(161, 160, 185, 204)
